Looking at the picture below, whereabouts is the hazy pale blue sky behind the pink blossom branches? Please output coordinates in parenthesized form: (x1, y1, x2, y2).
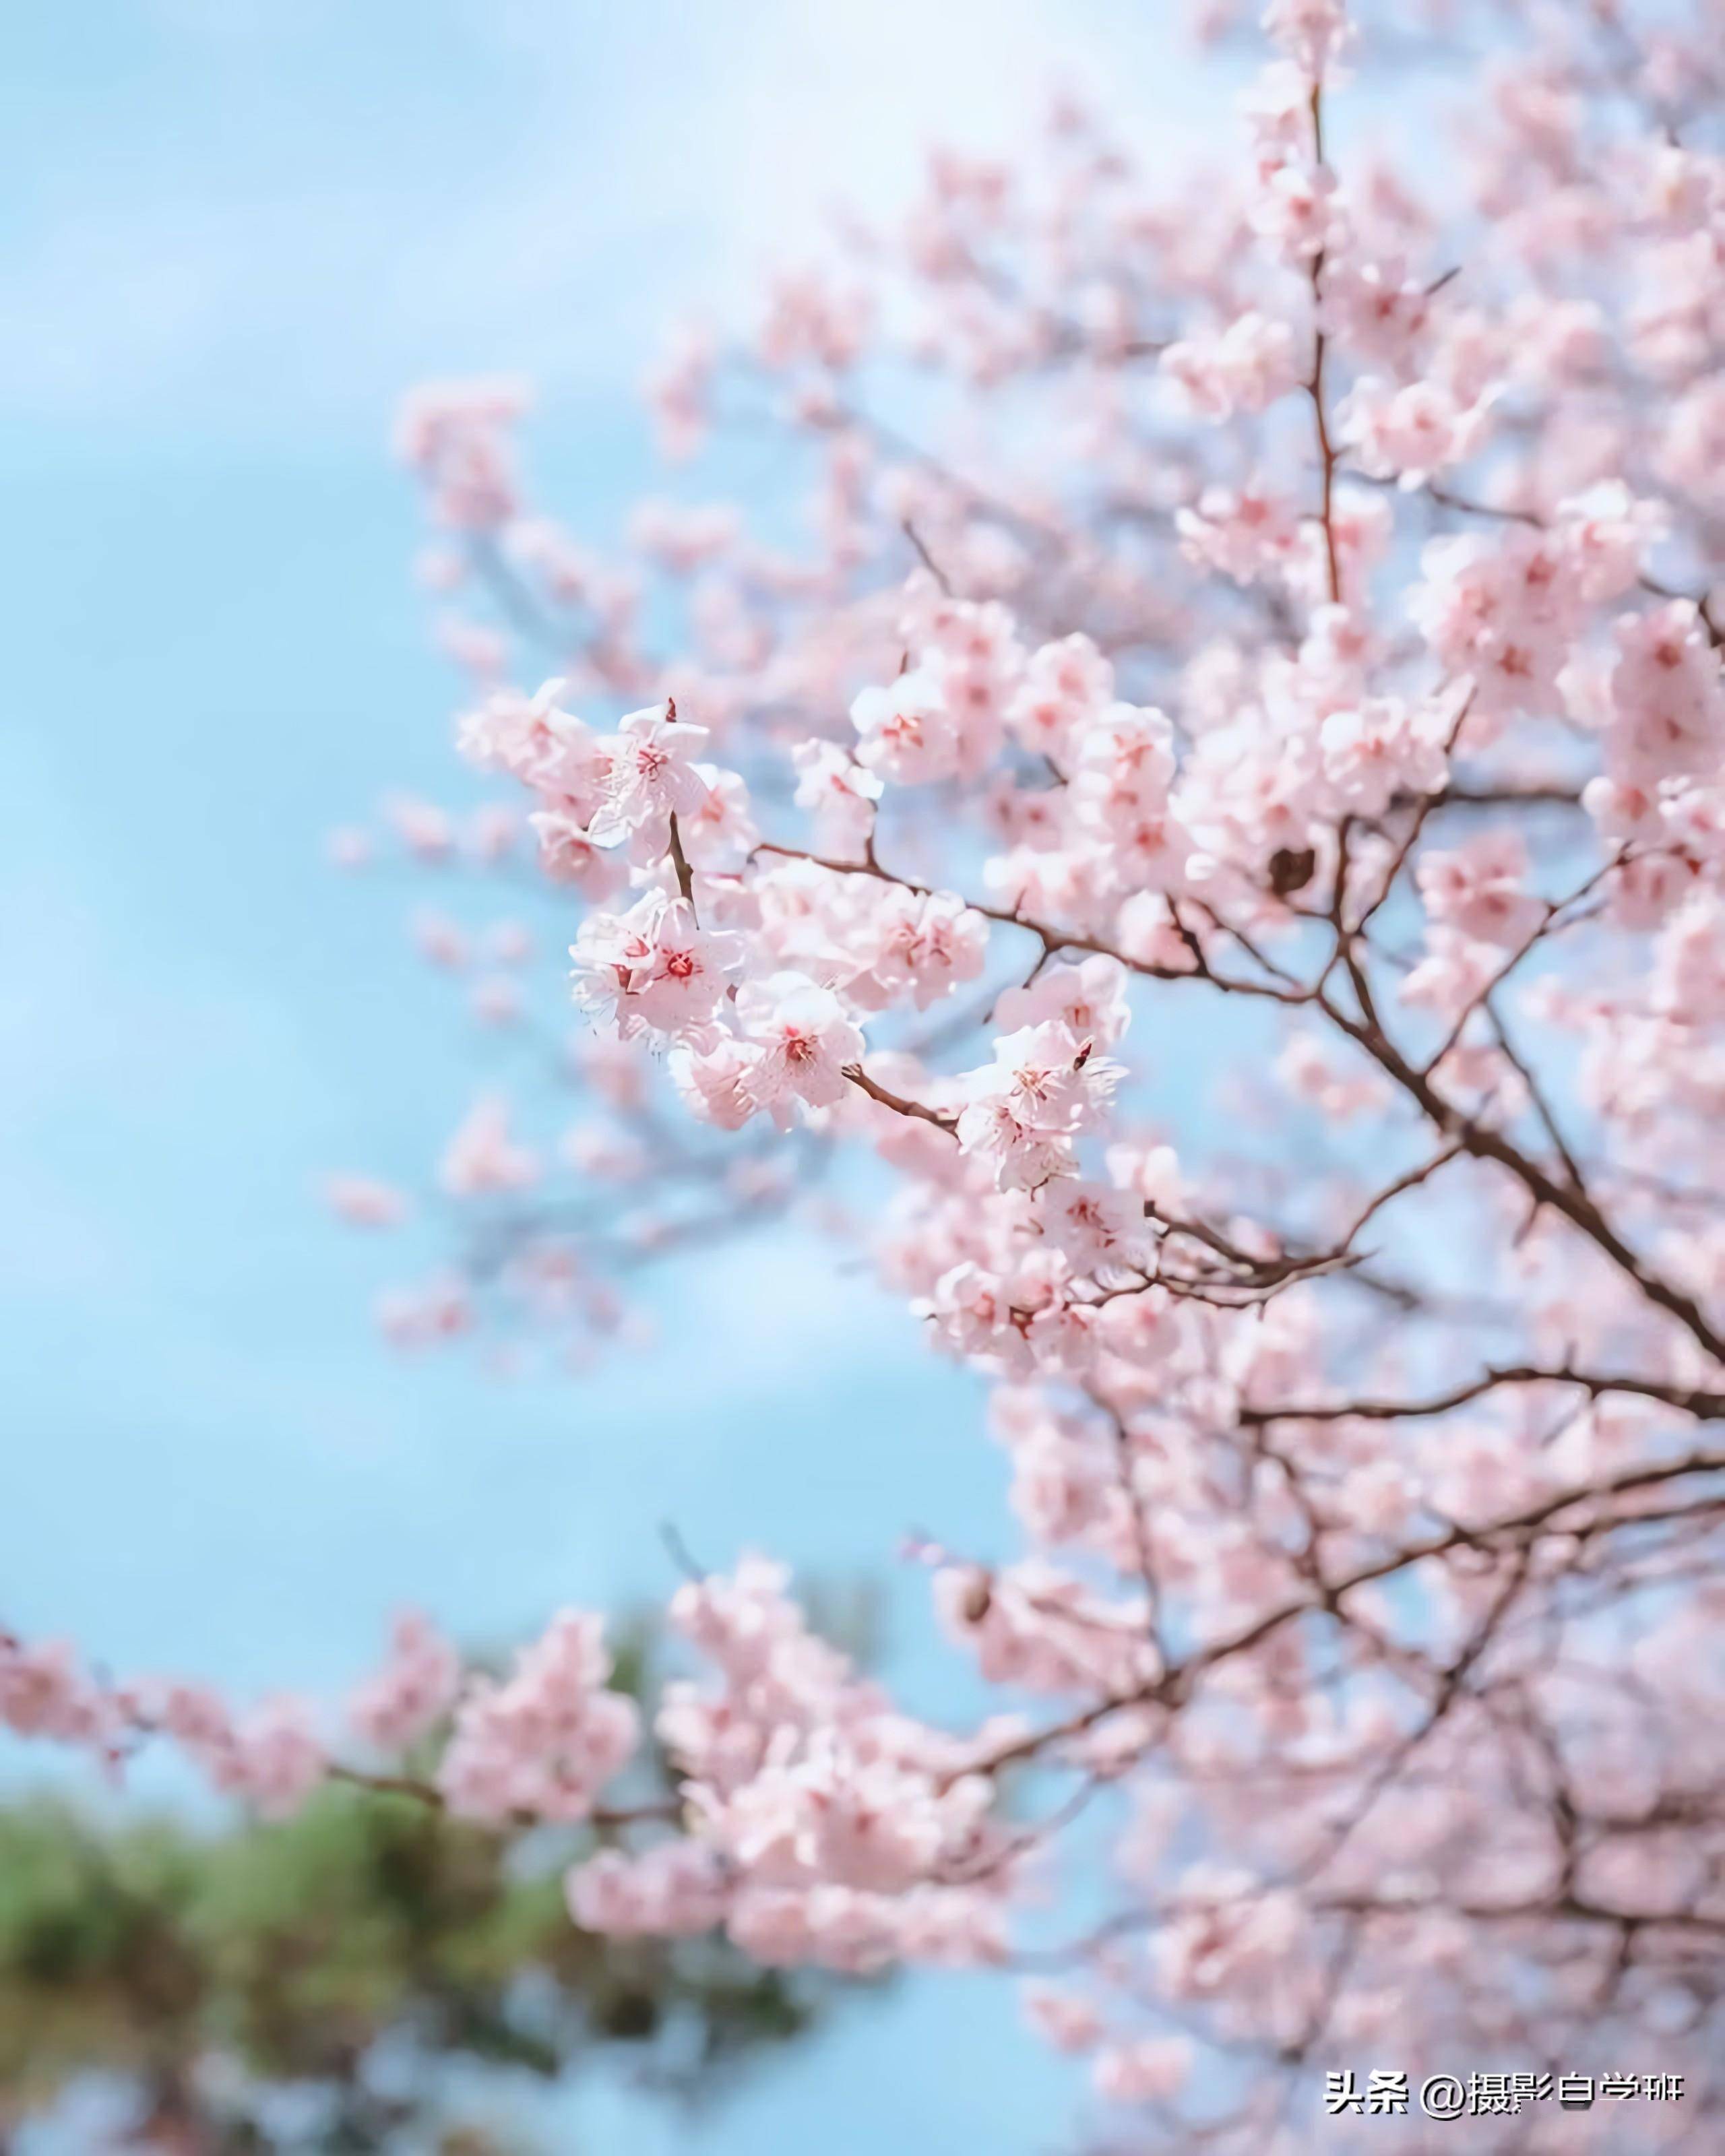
(0, 0, 1225, 2156)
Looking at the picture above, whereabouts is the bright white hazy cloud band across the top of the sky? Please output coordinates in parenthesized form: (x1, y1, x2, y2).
(0, 0, 1216, 431)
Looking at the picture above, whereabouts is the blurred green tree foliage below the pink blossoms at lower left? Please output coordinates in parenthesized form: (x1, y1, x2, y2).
(0, 1783, 815, 2152)
